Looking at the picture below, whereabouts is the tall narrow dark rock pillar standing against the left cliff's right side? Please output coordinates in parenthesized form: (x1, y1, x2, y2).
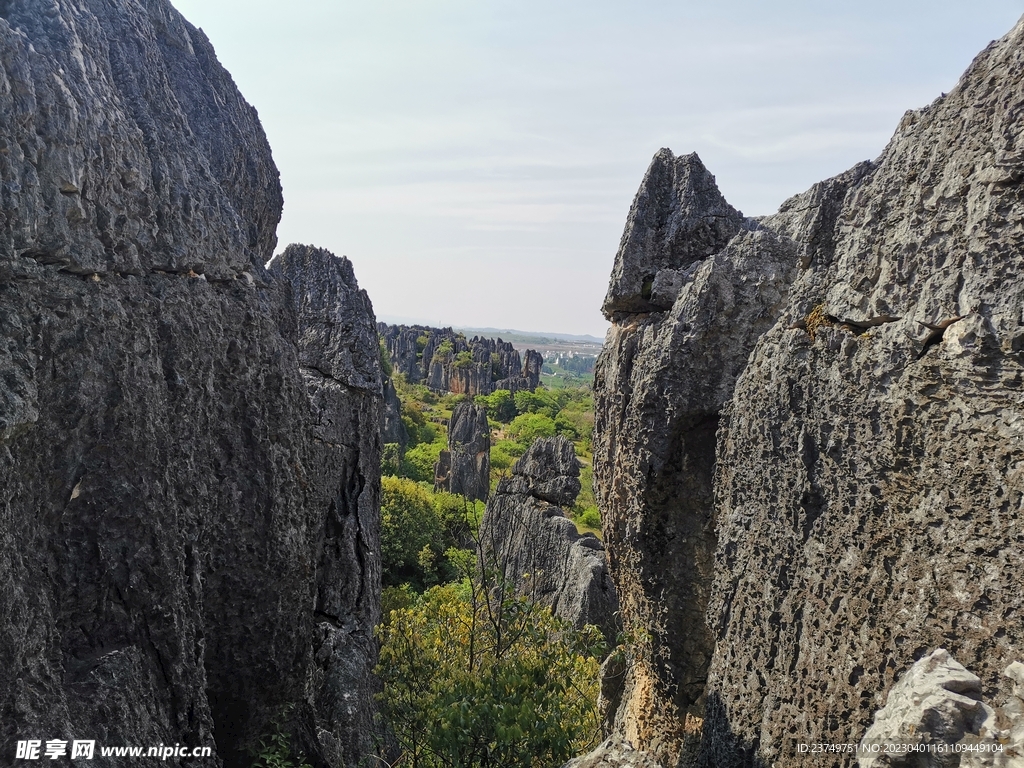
(269, 245, 383, 763)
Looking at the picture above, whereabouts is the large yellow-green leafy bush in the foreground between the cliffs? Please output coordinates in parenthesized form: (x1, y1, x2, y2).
(377, 573, 601, 768)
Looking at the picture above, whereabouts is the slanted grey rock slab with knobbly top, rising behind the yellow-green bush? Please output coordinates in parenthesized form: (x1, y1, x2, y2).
(480, 437, 618, 644)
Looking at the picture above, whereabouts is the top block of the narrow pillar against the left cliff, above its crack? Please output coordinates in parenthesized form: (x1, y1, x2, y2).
(268, 244, 383, 396)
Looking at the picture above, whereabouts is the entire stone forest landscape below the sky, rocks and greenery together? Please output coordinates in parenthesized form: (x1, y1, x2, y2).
(0, 0, 1024, 768)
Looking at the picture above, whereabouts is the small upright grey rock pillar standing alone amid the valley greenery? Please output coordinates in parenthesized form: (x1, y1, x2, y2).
(434, 402, 490, 502)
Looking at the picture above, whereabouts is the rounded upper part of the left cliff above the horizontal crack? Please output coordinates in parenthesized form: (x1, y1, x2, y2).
(0, 0, 282, 280)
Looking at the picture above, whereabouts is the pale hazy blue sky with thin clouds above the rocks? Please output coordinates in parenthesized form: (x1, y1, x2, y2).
(172, 0, 1024, 336)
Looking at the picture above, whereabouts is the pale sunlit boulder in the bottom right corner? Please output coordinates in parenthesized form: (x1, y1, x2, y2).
(857, 648, 1024, 768)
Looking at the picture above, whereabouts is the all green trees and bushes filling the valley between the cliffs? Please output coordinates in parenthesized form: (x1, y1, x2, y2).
(374, 338, 601, 768)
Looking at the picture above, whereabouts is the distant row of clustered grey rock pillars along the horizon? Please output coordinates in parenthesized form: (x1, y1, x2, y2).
(378, 323, 544, 395)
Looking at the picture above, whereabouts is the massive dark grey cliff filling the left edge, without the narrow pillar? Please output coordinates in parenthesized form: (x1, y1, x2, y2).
(0, 6, 377, 766)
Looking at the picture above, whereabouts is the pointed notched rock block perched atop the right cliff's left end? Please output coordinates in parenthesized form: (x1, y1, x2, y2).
(602, 148, 744, 319)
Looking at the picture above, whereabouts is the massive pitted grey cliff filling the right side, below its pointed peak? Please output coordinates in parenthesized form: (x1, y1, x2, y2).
(595, 13, 1024, 768)
